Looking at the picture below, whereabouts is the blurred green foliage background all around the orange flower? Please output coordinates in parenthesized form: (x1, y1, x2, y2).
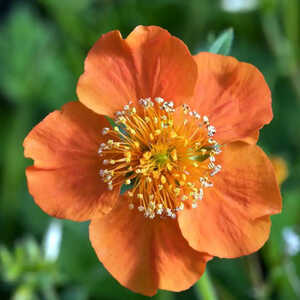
(0, 0, 300, 300)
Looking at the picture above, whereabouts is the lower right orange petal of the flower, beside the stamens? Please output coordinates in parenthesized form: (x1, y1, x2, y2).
(179, 142, 281, 257)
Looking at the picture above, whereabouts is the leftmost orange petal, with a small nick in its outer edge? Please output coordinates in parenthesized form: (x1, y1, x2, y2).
(24, 102, 119, 221)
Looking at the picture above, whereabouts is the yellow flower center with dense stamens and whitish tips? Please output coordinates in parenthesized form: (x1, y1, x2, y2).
(98, 97, 221, 219)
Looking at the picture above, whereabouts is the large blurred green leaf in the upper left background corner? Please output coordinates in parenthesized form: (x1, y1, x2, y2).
(0, 6, 75, 109)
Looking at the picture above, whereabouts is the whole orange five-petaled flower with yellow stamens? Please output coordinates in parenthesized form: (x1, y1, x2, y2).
(24, 26, 281, 295)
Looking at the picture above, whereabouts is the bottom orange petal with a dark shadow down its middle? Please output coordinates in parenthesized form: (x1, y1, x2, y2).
(90, 199, 211, 296)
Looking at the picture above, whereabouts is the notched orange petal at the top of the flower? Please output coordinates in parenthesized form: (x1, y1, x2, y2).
(77, 26, 197, 116)
